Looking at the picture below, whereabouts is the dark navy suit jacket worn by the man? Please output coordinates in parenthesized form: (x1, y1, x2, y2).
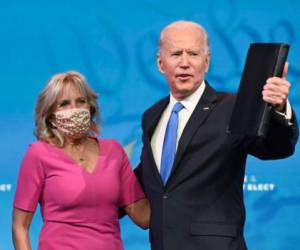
(135, 83, 298, 250)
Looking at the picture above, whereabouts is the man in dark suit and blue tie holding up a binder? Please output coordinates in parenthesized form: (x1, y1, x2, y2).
(136, 21, 298, 250)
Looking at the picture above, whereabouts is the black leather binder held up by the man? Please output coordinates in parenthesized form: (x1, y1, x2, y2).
(228, 43, 289, 136)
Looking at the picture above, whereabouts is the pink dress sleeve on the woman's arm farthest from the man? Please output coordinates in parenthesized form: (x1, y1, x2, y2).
(14, 143, 45, 212)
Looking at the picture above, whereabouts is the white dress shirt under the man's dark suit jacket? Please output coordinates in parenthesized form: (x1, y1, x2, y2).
(151, 81, 205, 172)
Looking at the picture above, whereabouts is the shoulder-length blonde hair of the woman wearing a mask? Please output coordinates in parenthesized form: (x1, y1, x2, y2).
(35, 71, 100, 147)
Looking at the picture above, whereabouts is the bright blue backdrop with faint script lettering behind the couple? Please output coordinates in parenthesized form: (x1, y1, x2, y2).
(0, 0, 300, 250)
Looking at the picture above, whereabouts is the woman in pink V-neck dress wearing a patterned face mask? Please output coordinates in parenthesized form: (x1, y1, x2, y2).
(13, 72, 150, 250)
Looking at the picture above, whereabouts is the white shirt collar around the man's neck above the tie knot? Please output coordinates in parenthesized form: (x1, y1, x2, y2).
(169, 80, 206, 111)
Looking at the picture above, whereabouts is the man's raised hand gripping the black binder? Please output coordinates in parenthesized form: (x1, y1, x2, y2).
(262, 62, 291, 112)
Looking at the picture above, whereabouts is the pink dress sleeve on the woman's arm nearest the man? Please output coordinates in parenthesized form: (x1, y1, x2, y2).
(118, 142, 145, 207)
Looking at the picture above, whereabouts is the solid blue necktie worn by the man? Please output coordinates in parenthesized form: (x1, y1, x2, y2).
(160, 102, 183, 184)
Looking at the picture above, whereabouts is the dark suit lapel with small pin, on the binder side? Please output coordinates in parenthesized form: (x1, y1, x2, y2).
(167, 82, 217, 185)
